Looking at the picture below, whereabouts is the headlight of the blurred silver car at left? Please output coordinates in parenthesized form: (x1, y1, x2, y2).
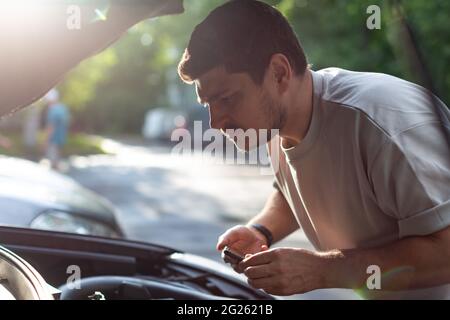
(31, 211, 119, 238)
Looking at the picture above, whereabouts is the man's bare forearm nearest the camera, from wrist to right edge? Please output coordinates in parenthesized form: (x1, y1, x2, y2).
(324, 228, 450, 290)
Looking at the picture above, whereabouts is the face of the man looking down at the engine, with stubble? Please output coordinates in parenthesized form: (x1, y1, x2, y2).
(195, 67, 281, 151)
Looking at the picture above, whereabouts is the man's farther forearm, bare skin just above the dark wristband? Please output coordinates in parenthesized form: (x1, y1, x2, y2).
(248, 190, 299, 242)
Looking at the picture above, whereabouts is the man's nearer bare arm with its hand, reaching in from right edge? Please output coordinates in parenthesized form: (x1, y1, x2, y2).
(239, 227, 450, 295)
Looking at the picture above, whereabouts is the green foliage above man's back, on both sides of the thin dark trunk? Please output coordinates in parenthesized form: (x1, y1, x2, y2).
(272, 0, 450, 103)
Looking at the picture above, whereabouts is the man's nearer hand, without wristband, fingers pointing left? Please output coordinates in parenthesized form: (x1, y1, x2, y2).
(238, 248, 327, 296)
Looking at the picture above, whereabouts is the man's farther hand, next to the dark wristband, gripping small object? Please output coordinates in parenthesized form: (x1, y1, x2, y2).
(217, 225, 268, 273)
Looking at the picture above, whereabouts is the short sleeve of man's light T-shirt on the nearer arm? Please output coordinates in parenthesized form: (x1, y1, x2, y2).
(370, 121, 450, 238)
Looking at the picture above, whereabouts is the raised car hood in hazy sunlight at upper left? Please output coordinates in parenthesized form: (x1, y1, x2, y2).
(0, 0, 183, 117)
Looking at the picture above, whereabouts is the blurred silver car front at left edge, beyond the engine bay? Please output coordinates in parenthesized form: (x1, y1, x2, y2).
(0, 156, 124, 238)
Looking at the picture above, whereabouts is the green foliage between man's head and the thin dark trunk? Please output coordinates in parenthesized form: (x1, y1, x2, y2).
(278, 0, 400, 74)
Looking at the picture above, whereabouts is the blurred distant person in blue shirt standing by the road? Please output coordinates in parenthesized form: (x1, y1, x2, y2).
(45, 89, 69, 170)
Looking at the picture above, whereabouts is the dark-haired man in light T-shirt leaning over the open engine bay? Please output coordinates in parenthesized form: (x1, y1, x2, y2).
(179, 0, 450, 298)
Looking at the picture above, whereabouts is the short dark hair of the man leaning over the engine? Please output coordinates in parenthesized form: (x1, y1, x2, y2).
(178, 0, 307, 84)
